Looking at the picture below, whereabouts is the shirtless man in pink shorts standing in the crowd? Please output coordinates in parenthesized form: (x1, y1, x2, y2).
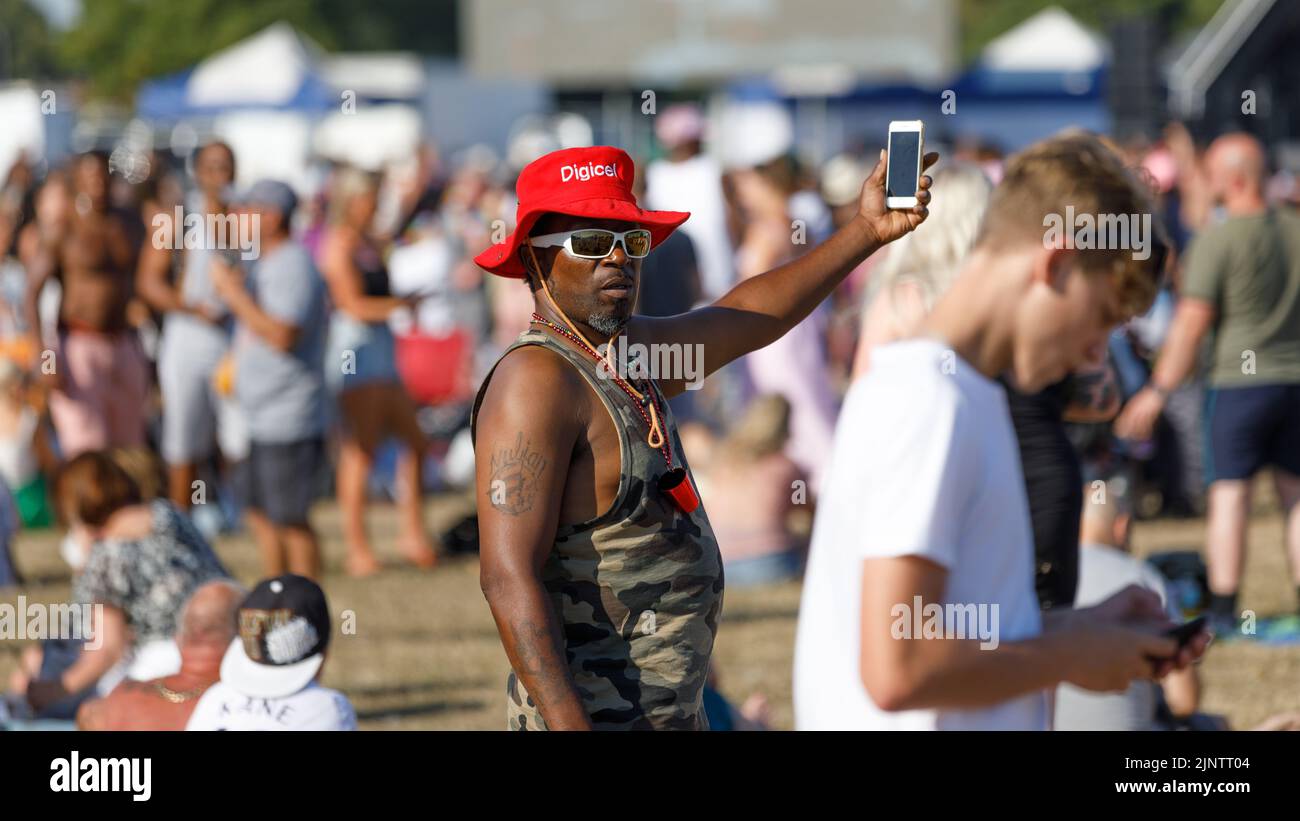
(27, 152, 148, 457)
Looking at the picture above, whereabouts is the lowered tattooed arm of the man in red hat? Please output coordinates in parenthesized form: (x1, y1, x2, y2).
(475, 348, 590, 730)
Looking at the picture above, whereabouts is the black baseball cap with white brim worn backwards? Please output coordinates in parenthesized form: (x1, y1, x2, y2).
(221, 574, 330, 699)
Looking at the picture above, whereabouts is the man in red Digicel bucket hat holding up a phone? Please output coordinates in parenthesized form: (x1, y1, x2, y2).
(472, 145, 939, 730)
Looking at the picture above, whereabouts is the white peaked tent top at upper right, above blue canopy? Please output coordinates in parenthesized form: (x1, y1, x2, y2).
(979, 5, 1110, 73)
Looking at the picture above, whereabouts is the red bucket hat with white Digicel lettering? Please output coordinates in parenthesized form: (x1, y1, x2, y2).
(475, 145, 690, 279)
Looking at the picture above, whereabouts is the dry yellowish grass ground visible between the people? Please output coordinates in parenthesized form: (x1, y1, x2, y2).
(0, 475, 1300, 730)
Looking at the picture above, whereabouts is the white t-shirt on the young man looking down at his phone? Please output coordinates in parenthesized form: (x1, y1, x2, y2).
(794, 339, 1050, 730)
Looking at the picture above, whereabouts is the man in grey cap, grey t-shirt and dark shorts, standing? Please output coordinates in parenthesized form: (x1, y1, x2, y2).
(212, 179, 328, 578)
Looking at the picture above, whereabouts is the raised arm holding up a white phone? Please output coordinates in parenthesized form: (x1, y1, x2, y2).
(628, 151, 939, 396)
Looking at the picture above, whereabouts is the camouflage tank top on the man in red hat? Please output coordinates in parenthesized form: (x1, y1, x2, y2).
(471, 329, 723, 730)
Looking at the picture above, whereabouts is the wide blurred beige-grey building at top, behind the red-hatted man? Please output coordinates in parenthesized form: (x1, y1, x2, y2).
(462, 0, 959, 161)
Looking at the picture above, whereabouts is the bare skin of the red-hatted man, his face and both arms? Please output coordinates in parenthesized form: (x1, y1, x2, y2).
(476, 152, 939, 730)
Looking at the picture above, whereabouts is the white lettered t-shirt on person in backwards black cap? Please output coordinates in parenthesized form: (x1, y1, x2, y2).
(185, 682, 356, 730)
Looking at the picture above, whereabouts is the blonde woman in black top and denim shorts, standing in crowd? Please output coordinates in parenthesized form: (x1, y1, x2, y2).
(320, 169, 437, 575)
